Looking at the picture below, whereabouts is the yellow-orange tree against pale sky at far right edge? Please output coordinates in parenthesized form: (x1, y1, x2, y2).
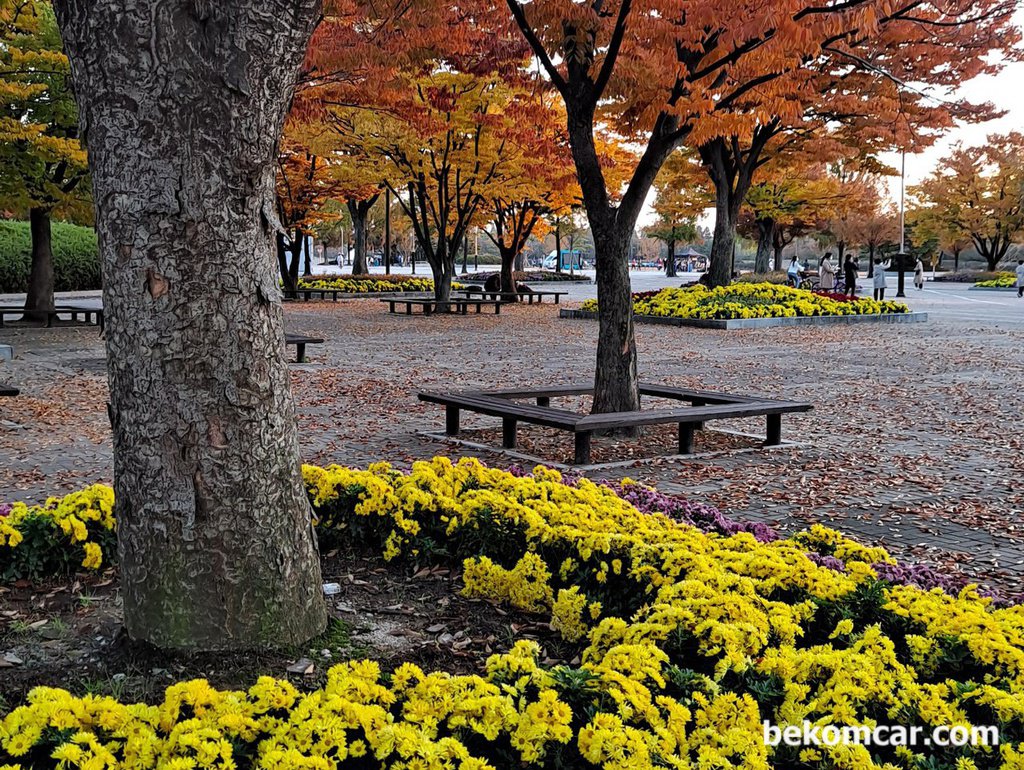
(911, 132, 1024, 270)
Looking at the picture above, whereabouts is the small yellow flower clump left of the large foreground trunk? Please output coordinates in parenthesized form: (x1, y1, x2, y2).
(0, 484, 116, 576)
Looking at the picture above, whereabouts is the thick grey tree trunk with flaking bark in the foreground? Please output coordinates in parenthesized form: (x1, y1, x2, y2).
(54, 0, 327, 649)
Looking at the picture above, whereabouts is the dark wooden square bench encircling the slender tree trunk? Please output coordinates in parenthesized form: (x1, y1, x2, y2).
(419, 384, 813, 465)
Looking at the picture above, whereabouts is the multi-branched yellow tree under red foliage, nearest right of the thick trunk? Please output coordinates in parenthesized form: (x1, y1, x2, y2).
(301, 0, 537, 302)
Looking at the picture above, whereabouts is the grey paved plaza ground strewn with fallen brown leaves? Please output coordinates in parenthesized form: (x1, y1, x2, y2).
(0, 273, 1024, 589)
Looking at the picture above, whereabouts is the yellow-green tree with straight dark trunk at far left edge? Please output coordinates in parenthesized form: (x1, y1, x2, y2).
(0, 0, 91, 320)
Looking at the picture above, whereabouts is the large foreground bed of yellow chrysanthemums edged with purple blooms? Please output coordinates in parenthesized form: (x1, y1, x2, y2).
(0, 459, 1024, 770)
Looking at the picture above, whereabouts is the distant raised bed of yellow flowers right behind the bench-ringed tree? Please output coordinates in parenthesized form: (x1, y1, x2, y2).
(582, 284, 909, 320)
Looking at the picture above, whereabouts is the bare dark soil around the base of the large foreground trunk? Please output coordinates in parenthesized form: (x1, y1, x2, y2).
(0, 550, 561, 715)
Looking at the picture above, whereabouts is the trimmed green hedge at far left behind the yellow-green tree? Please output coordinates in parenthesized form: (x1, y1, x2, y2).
(0, 221, 100, 294)
